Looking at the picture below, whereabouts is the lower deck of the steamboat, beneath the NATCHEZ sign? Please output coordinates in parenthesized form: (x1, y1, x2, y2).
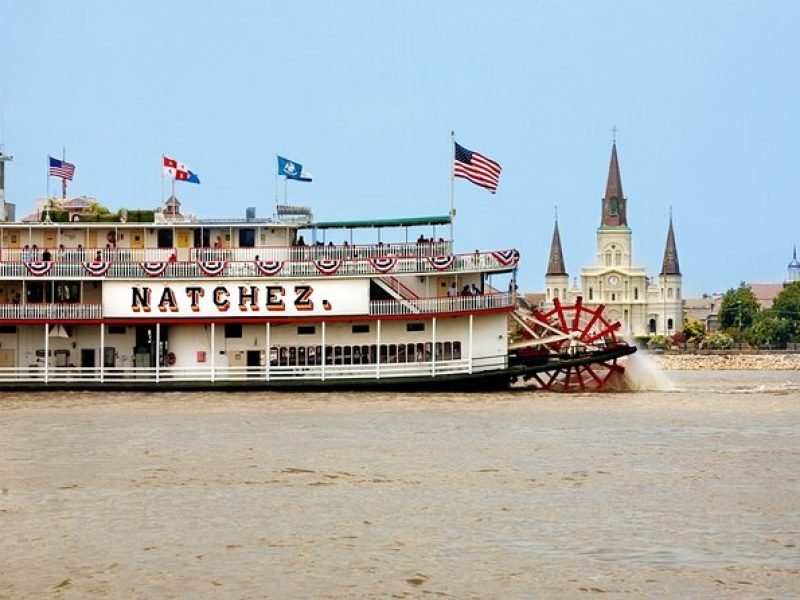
(0, 313, 508, 387)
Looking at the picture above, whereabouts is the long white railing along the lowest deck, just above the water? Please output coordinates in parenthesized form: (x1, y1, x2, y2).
(0, 356, 508, 386)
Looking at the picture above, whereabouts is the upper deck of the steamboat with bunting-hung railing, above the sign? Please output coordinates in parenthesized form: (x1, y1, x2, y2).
(0, 210, 518, 280)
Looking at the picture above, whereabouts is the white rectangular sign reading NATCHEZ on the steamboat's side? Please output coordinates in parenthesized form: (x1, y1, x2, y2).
(103, 280, 369, 318)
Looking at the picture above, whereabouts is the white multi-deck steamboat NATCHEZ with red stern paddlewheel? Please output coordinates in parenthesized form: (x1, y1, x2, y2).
(0, 155, 635, 391)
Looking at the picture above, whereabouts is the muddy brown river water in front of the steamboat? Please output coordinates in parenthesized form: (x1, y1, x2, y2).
(0, 371, 800, 599)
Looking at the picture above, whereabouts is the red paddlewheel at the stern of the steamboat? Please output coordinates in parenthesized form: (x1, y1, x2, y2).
(519, 296, 629, 392)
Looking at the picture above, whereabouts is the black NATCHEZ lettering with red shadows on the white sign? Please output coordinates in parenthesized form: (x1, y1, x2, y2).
(131, 285, 326, 313)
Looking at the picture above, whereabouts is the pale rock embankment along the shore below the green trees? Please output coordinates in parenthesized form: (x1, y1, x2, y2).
(649, 352, 800, 371)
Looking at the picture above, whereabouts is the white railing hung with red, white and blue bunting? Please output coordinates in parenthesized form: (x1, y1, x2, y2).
(0, 250, 513, 279)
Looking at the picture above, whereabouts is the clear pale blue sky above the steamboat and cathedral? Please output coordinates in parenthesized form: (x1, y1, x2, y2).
(0, 0, 800, 294)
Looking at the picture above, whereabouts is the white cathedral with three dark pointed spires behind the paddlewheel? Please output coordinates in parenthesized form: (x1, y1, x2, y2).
(545, 143, 683, 336)
